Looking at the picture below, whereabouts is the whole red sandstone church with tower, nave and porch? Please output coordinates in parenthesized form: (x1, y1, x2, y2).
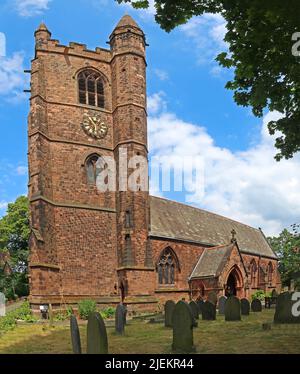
(28, 15, 280, 311)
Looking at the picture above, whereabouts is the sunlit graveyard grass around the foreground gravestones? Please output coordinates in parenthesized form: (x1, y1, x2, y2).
(0, 309, 300, 354)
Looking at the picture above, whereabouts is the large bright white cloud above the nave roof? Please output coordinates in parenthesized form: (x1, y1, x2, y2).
(148, 94, 300, 235)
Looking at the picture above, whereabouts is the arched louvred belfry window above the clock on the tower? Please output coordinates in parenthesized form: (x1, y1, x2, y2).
(78, 69, 105, 108)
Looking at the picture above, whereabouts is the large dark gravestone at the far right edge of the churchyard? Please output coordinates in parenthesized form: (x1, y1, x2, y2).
(274, 292, 300, 323)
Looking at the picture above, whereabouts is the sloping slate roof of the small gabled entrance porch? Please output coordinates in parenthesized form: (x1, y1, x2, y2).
(190, 243, 235, 279)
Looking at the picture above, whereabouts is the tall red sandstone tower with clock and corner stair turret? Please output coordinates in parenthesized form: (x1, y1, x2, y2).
(28, 16, 156, 309)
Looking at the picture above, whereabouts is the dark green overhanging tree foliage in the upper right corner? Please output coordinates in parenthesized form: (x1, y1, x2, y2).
(116, 0, 300, 161)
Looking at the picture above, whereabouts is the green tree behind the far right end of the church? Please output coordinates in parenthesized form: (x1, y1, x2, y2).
(269, 225, 300, 287)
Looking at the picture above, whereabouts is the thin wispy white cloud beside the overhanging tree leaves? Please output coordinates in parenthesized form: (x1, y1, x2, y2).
(180, 13, 228, 76)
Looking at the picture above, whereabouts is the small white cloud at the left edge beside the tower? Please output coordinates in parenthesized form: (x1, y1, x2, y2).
(0, 52, 29, 101)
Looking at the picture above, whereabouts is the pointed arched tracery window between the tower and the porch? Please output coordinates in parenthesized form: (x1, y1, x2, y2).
(157, 247, 179, 285)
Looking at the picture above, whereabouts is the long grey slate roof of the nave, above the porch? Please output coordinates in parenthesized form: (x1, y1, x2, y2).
(150, 196, 277, 259)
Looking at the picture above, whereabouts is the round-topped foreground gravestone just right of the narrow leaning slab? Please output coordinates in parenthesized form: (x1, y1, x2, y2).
(87, 312, 108, 354)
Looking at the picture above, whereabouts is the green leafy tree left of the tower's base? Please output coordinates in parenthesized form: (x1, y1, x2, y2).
(0, 196, 30, 298)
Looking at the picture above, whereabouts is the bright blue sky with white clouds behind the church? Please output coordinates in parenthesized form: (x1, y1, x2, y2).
(0, 0, 300, 236)
